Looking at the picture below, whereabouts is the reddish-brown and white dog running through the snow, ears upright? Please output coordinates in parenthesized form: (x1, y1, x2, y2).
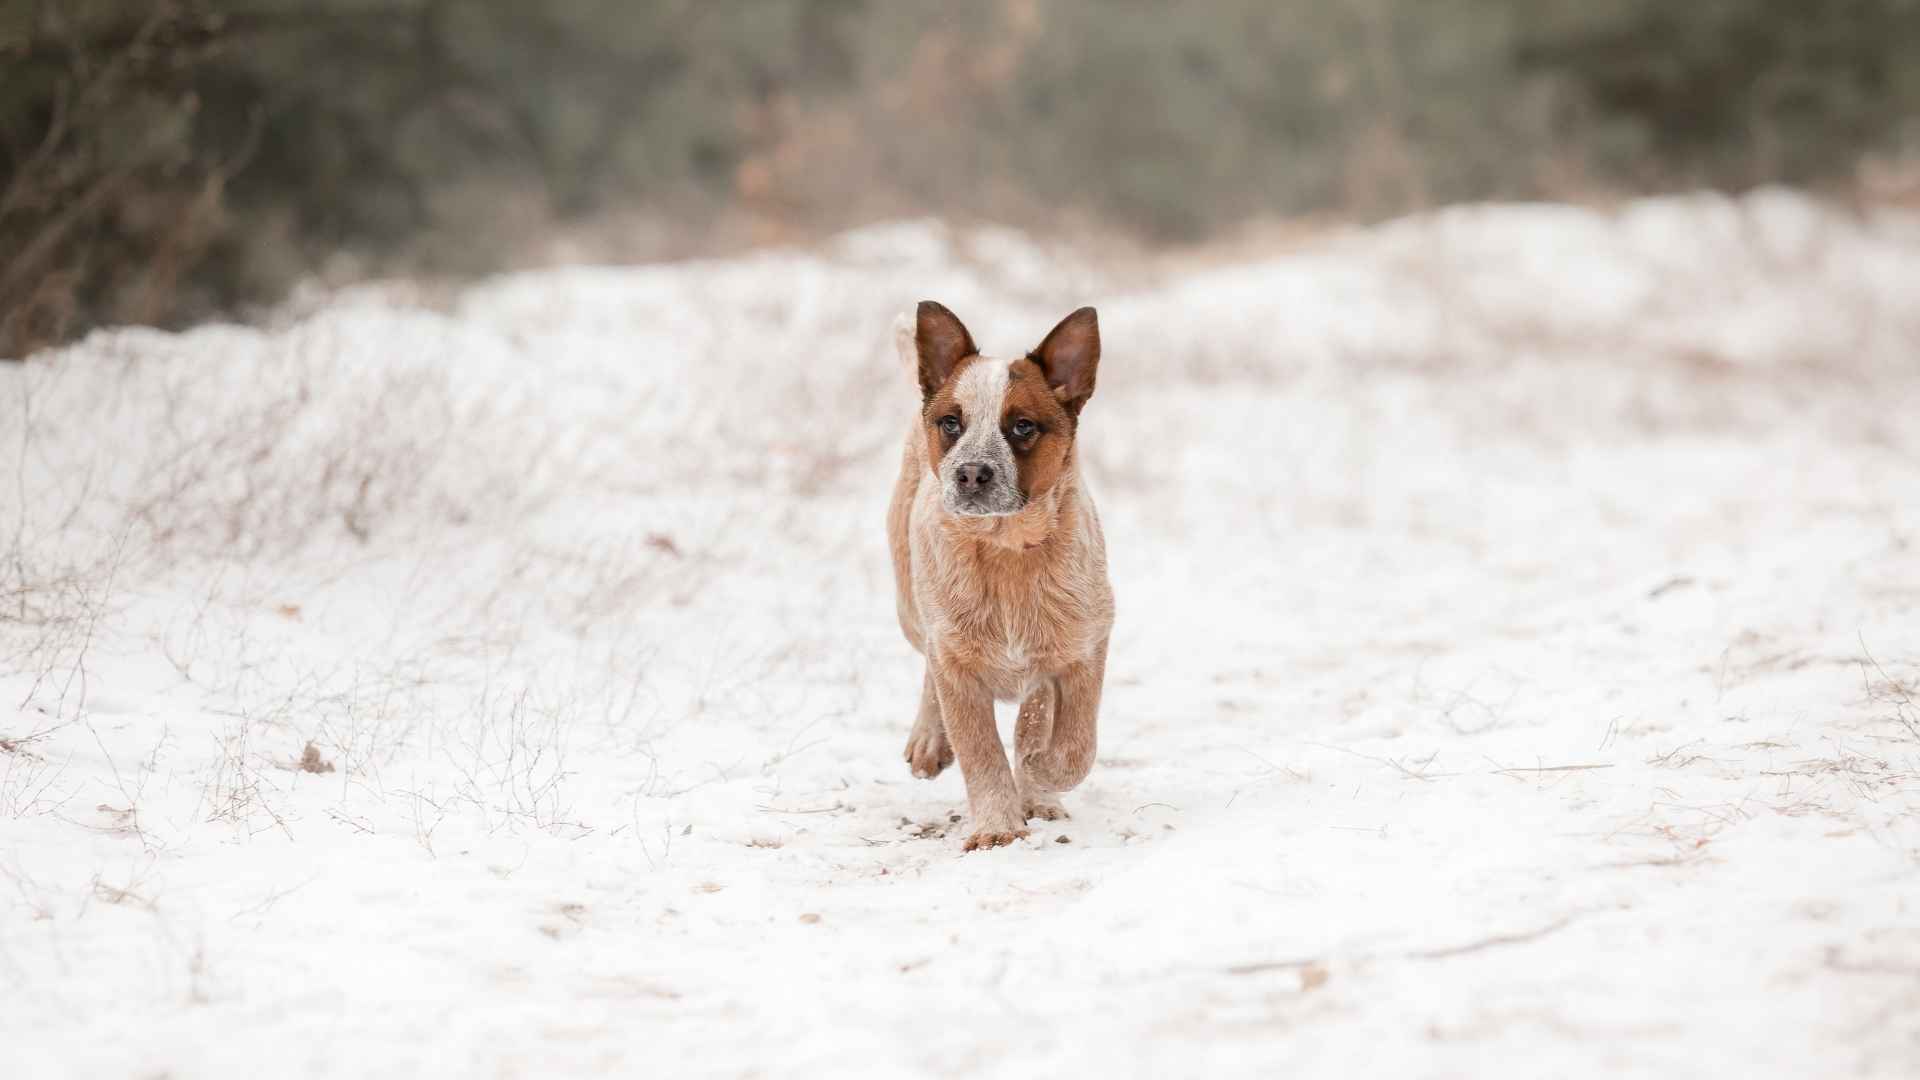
(887, 302, 1114, 851)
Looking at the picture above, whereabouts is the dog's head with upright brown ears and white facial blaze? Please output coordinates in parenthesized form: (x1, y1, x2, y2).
(914, 300, 1100, 517)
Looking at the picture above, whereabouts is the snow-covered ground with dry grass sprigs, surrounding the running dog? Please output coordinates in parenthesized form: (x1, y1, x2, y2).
(11, 192, 1920, 1078)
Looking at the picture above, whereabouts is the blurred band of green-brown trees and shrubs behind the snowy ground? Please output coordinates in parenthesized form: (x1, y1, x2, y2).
(0, 0, 1920, 357)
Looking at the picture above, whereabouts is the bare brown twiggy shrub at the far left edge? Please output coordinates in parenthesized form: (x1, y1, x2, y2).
(0, 0, 232, 356)
